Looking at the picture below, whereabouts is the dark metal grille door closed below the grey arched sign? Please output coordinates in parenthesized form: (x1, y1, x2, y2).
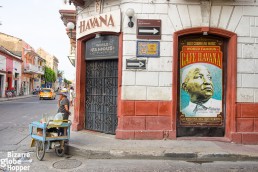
(85, 60, 118, 134)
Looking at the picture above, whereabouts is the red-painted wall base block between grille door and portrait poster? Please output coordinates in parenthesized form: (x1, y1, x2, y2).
(116, 100, 172, 139)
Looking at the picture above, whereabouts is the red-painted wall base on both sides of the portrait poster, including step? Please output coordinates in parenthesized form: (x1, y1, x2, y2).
(116, 100, 258, 144)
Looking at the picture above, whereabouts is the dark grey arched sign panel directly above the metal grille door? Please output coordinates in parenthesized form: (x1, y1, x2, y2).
(85, 35, 118, 60)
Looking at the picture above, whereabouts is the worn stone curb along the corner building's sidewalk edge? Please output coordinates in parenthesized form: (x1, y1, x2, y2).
(66, 145, 258, 162)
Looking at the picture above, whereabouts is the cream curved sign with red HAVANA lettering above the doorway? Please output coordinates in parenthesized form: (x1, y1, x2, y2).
(76, 10, 121, 39)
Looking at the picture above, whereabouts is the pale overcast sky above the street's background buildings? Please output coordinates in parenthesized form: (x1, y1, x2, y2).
(0, 0, 75, 80)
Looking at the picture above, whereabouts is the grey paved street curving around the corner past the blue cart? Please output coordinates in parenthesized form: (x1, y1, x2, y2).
(0, 97, 258, 172)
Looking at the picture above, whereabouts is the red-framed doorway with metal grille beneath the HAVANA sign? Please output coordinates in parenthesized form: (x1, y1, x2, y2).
(73, 33, 123, 134)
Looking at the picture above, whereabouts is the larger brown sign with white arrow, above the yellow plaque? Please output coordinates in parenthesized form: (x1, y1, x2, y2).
(137, 19, 161, 39)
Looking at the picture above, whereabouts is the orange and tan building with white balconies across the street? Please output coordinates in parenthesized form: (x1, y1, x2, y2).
(0, 33, 45, 95)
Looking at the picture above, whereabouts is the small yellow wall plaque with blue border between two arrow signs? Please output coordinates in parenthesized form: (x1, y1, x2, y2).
(136, 41, 160, 57)
